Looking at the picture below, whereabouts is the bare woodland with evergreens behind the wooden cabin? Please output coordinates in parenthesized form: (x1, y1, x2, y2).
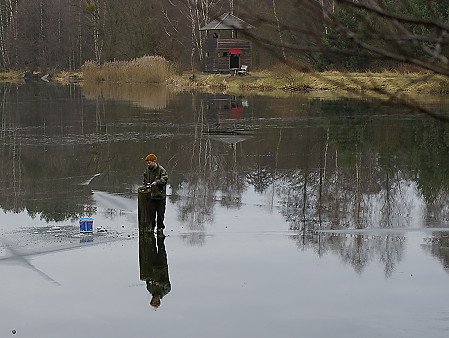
(0, 0, 449, 75)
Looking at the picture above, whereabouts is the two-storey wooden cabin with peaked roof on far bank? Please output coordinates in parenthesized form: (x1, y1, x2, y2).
(200, 13, 253, 73)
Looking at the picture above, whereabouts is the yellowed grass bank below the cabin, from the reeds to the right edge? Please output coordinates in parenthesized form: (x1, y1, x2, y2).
(184, 67, 449, 93)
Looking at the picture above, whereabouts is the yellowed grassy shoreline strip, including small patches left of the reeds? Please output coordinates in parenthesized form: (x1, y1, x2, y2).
(4, 71, 449, 96)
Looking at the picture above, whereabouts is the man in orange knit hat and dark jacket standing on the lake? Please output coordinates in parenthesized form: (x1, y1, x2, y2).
(143, 154, 168, 234)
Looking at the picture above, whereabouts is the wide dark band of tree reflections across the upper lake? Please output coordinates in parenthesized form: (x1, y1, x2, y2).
(0, 84, 449, 276)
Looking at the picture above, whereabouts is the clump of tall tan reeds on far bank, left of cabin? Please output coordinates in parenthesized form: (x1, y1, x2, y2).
(81, 56, 176, 83)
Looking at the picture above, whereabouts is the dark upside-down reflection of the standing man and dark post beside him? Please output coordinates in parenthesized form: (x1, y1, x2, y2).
(139, 233, 171, 308)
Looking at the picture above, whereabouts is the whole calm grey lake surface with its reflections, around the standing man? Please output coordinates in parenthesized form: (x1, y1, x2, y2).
(0, 83, 449, 338)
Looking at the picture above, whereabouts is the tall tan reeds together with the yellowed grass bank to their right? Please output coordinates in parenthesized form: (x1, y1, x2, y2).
(43, 56, 449, 95)
